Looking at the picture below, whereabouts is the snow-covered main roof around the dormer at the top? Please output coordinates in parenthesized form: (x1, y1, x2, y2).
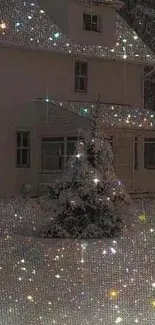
(0, 0, 155, 64)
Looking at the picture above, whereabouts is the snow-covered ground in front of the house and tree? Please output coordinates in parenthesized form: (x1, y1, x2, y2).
(0, 199, 155, 325)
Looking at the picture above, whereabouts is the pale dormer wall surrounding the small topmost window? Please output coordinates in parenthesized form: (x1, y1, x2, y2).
(68, 0, 116, 48)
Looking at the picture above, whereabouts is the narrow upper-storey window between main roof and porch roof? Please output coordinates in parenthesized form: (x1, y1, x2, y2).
(75, 62, 88, 93)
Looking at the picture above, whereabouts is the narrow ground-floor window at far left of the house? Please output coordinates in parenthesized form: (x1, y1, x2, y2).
(16, 131, 30, 168)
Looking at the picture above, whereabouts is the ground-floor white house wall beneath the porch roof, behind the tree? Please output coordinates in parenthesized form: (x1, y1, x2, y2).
(0, 97, 155, 196)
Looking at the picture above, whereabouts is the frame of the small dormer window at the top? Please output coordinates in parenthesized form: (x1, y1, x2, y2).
(83, 12, 101, 33)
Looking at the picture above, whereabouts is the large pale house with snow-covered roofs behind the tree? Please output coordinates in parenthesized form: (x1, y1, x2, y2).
(0, 0, 155, 196)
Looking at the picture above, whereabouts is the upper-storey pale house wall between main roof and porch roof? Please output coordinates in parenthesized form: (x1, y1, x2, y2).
(0, 47, 143, 108)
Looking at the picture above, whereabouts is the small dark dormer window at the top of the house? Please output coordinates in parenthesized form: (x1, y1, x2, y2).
(83, 13, 101, 33)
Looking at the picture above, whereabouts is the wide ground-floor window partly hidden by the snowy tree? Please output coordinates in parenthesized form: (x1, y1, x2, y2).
(41, 137, 76, 172)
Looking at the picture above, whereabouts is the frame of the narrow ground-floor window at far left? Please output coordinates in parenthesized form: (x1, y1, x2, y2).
(15, 130, 31, 168)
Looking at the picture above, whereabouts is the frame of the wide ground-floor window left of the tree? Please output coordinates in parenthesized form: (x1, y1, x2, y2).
(40, 137, 77, 174)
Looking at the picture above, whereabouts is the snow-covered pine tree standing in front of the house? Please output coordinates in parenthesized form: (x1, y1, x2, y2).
(43, 98, 129, 239)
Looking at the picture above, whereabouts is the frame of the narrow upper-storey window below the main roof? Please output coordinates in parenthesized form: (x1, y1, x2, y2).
(74, 60, 88, 93)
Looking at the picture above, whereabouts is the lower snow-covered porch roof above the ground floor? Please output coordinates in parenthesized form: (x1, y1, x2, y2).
(40, 98, 155, 130)
